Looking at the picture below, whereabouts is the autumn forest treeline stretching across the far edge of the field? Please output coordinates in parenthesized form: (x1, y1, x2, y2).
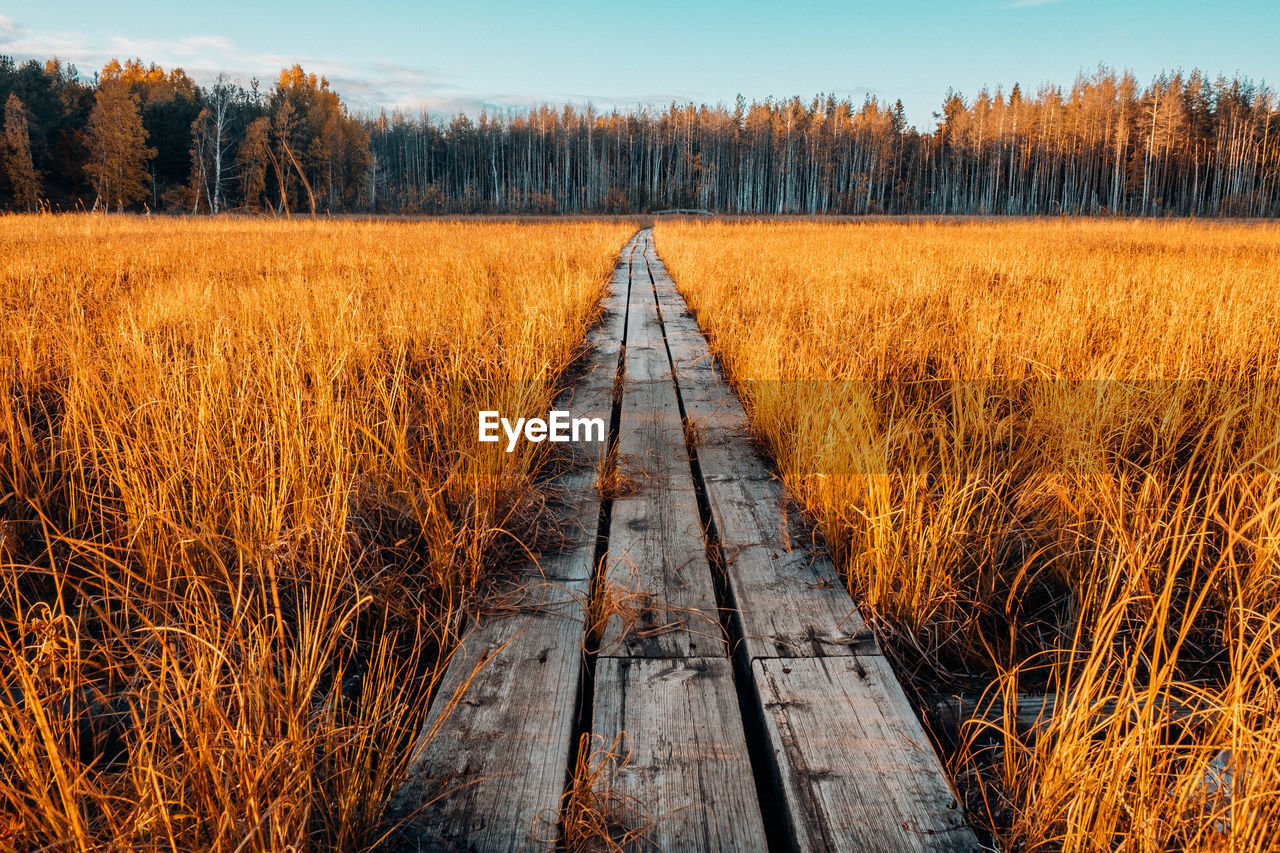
(0, 56, 1280, 216)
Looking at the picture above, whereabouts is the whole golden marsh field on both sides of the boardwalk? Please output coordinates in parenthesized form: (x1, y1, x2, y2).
(0, 215, 1280, 852)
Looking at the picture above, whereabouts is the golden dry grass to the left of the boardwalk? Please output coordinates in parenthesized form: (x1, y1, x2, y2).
(0, 216, 631, 852)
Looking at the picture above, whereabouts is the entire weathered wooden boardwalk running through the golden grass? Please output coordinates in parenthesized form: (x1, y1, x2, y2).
(393, 231, 979, 853)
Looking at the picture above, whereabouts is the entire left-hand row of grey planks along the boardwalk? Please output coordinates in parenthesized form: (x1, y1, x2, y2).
(393, 230, 636, 852)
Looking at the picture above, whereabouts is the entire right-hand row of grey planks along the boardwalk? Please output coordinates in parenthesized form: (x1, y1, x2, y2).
(649, 230, 977, 850)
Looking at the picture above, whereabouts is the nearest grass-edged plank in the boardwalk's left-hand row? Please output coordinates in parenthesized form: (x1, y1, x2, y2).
(394, 573, 588, 850)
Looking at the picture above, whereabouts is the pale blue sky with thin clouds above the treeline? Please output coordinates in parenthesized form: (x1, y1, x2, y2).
(0, 0, 1280, 127)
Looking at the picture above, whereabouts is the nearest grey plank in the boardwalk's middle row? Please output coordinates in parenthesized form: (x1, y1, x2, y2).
(593, 657, 767, 850)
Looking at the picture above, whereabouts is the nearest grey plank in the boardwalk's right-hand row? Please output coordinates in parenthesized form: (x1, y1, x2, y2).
(751, 656, 979, 853)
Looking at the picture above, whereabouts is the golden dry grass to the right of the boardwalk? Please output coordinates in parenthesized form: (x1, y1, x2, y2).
(657, 220, 1280, 850)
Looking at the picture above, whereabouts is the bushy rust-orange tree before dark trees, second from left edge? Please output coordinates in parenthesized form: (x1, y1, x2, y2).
(84, 79, 156, 210)
